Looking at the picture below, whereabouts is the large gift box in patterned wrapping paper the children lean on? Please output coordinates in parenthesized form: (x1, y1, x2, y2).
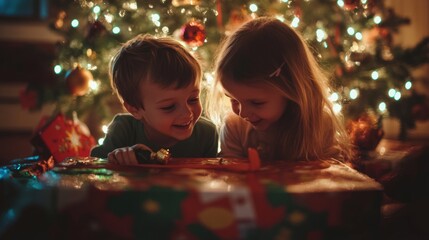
(0, 159, 381, 239)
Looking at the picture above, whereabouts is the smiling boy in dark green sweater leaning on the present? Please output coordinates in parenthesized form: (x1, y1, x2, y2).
(91, 35, 218, 164)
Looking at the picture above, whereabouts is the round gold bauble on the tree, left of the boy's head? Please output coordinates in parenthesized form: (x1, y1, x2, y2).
(66, 66, 93, 96)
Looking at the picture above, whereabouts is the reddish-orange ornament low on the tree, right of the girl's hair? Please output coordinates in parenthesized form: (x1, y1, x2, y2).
(347, 113, 384, 151)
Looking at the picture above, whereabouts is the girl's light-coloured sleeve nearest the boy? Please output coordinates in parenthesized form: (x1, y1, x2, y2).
(219, 114, 247, 158)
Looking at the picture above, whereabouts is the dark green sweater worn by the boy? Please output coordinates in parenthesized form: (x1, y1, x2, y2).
(91, 114, 219, 158)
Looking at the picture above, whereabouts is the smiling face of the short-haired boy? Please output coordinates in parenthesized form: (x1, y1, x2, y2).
(138, 81, 202, 145)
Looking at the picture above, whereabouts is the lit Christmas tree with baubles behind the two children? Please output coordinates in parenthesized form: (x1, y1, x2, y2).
(21, 0, 429, 142)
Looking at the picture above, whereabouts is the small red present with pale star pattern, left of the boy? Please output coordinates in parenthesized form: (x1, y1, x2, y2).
(31, 113, 95, 162)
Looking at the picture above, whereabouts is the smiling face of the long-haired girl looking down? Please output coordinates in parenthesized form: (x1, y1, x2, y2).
(222, 80, 287, 130)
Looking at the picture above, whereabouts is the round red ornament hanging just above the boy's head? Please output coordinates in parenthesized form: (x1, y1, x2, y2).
(180, 20, 206, 47)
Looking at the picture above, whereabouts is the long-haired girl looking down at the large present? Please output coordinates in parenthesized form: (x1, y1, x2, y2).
(207, 17, 352, 161)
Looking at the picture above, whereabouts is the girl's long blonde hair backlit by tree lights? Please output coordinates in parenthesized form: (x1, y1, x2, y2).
(206, 17, 353, 160)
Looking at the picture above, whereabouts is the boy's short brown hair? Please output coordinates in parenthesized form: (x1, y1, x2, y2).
(109, 34, 202, 108)
